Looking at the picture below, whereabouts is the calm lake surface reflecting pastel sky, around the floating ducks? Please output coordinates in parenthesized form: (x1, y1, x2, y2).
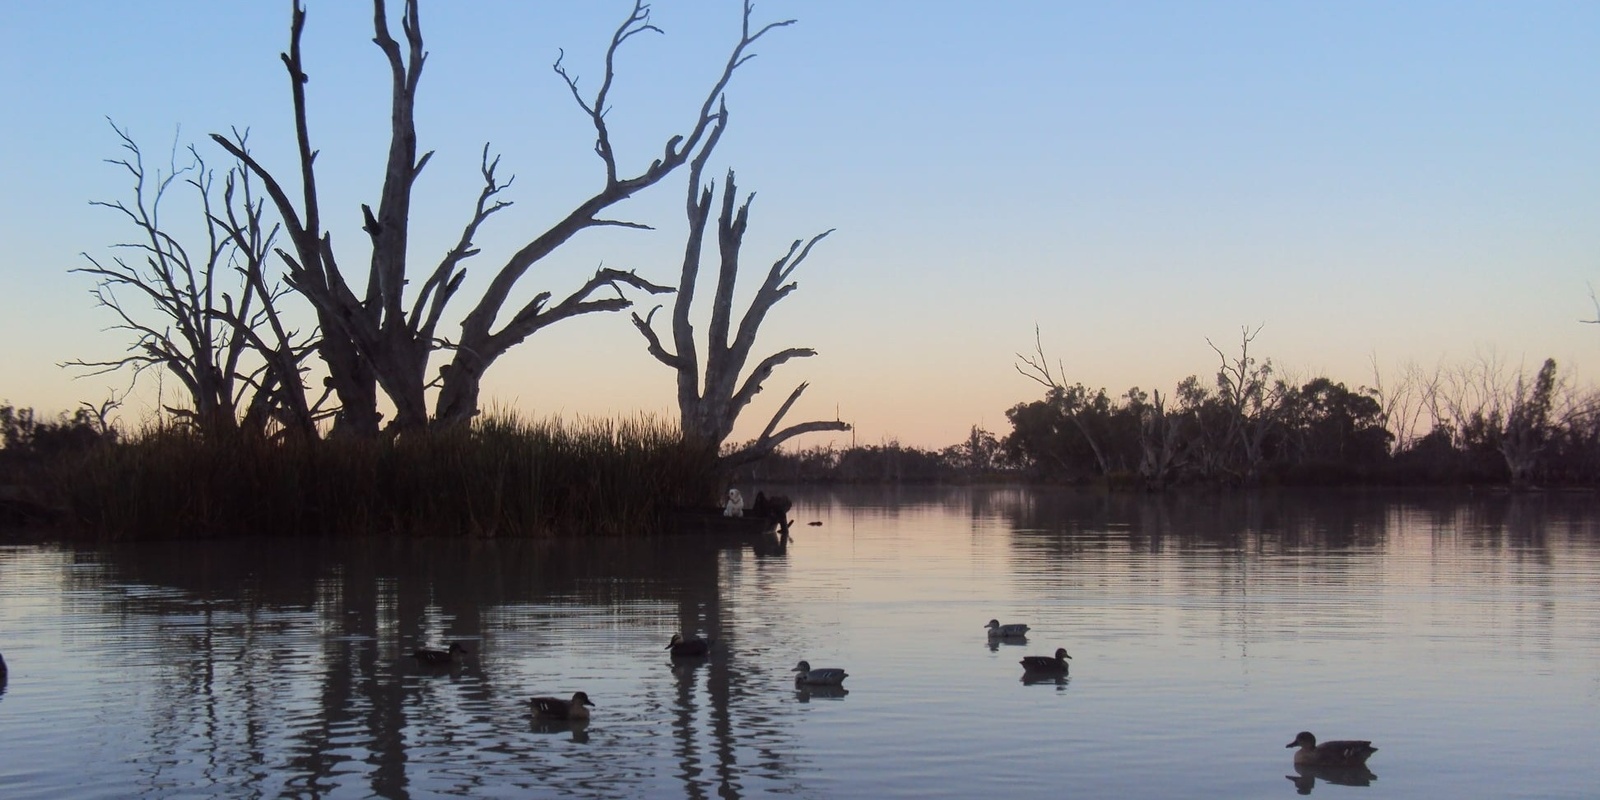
(0, 490, 1600, 800)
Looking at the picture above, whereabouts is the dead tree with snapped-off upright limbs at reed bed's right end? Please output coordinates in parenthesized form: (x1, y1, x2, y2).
(634, 168, 850, 469)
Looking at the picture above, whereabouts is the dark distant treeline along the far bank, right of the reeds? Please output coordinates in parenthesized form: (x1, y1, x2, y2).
(741, 358, 1600, 488)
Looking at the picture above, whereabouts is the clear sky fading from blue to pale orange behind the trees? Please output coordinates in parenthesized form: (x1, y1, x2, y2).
(0, 0, 1600, 448)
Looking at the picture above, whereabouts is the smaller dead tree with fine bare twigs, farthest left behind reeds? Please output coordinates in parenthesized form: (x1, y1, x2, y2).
(66, 123, 324, 435)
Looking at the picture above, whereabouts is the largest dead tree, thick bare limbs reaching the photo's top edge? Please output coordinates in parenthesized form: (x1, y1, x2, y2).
(213, 0, 792, 435)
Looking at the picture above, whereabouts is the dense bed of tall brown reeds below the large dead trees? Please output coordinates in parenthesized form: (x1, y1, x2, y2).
(54, 414, 718, 539)
